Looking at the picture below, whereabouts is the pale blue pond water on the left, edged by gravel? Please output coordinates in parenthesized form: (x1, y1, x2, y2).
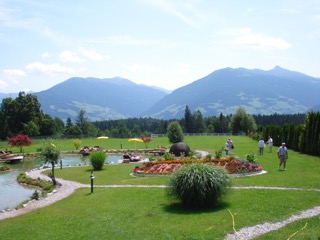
(0, 155, 122, 210)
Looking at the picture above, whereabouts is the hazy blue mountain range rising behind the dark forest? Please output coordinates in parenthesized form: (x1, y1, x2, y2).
(0, 67, 320, 121)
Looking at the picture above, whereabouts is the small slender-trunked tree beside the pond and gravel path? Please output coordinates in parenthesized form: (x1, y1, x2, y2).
(40, 141, 60, 186)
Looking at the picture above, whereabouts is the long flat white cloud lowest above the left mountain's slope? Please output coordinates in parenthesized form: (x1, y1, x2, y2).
(26, 62, 76, 74)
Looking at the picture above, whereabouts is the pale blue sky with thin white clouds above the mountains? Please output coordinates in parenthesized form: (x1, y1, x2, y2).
(0, 0, 320, 93)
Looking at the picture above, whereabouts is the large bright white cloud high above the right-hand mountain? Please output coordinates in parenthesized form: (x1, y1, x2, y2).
(234, 28, 291, 49)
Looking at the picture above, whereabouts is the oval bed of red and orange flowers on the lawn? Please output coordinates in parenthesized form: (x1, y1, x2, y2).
(133, 158, 262, 175)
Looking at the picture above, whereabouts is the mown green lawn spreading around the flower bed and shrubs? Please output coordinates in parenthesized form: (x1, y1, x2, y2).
(0, 136, 320, 240)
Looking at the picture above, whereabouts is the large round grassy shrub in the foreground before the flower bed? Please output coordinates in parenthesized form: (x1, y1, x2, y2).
(167, 163, 231, 209)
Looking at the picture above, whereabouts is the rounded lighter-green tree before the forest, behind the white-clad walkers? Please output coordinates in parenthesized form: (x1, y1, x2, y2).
(230, 107, 257, 134)
